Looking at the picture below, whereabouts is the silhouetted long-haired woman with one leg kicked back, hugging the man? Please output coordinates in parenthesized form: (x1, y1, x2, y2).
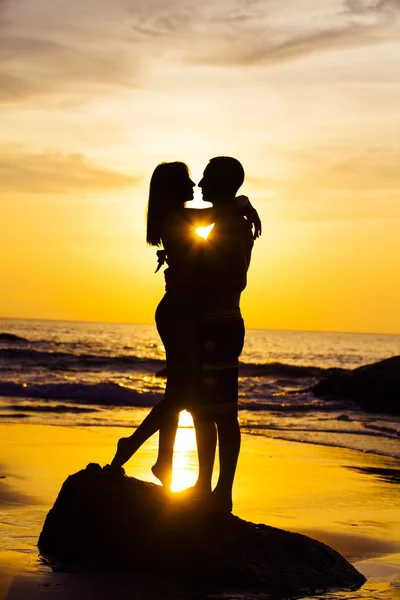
(112, 162, 260, 488)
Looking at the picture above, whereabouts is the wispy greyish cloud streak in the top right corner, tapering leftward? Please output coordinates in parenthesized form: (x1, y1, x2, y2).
(189, 0, 400, 66)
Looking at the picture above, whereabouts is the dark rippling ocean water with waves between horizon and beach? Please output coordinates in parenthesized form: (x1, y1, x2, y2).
(0, 319, 400, 458)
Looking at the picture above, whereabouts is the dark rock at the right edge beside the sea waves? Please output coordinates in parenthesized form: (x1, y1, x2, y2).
(313, 356, 400, 415)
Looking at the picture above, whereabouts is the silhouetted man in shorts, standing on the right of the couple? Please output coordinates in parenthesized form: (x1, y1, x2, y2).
(192, 156, 255, 512)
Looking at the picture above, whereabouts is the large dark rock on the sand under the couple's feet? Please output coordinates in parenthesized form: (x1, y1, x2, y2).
(38, 464, 365, 598)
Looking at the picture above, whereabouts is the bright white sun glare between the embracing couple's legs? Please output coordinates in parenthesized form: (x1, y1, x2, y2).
(171, 411, 197, 492)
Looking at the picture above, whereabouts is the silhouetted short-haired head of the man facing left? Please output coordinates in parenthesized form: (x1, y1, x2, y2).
(199, 156, 244, 204)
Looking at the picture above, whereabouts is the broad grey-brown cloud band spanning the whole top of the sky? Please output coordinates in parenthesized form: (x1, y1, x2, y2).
(0, 0, 400, 103)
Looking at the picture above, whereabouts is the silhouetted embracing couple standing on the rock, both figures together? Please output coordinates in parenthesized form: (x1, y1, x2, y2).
(112, 156, 261, 512)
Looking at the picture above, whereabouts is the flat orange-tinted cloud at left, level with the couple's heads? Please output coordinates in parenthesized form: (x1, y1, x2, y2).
(0, 148, 141, 194)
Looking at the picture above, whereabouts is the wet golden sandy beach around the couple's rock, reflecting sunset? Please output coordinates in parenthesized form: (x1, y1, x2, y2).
(0, 420, 400, 600)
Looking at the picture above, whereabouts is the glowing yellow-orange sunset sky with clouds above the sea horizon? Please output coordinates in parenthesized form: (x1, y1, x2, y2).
(0, 0, 400, 333)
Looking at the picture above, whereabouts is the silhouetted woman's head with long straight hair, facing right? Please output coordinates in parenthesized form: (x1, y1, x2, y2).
(146, 161, 190, 246)
